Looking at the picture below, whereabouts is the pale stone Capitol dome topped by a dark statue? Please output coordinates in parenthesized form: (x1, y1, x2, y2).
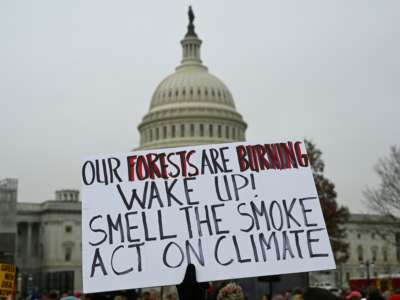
(138, 8, 247, 149)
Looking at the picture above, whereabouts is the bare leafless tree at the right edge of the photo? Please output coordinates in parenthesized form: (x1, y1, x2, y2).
(364, 146, 400, 218)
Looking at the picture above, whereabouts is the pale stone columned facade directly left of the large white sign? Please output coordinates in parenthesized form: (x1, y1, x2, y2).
(16, 190, 82, 292)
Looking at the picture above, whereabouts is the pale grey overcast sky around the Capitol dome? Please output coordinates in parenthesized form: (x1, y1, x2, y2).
(0, 0, 400, 211)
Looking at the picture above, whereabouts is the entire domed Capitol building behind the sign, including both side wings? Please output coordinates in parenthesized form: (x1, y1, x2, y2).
(0, 10, 400, 295)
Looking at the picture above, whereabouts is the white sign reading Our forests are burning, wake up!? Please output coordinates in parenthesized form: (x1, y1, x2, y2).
(81, 140, 335, 293)
